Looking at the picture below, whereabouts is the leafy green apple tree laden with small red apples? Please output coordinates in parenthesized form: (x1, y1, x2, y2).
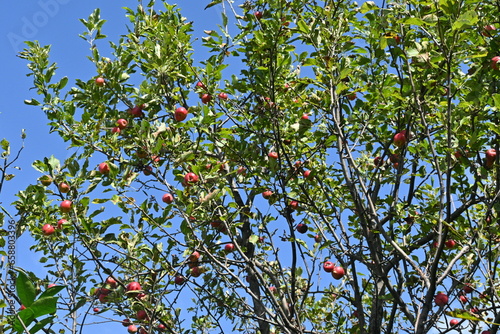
(8, 0, 500, 334)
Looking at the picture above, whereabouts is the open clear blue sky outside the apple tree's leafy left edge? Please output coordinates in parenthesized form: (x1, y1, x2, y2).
(0, 0, 220, 334)
